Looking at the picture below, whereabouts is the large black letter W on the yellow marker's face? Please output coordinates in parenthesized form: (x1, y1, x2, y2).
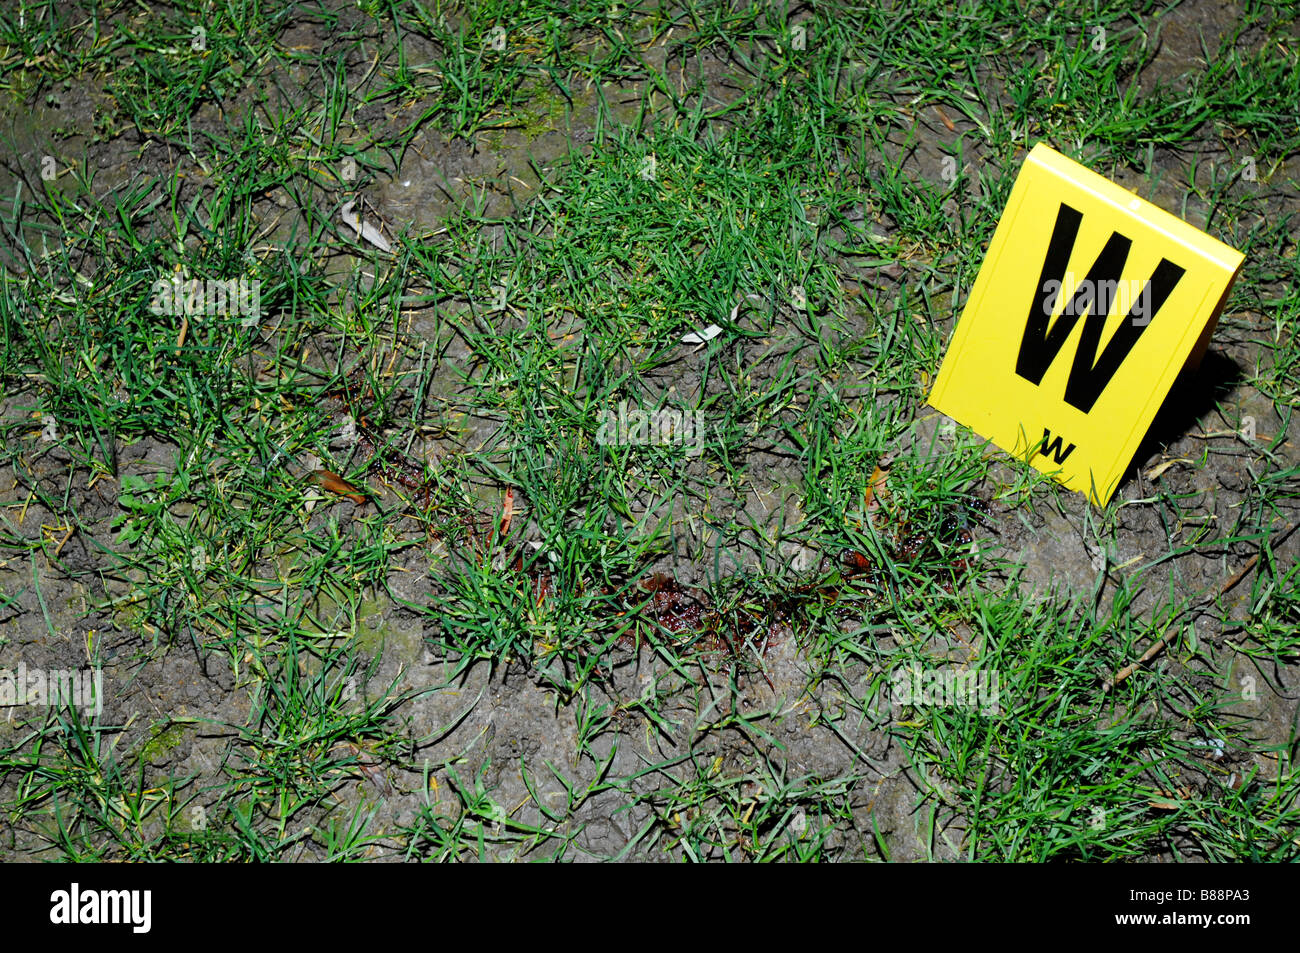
(1015, 202, 1184, 413)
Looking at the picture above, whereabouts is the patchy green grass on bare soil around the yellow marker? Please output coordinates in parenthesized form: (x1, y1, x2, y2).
(0, 3, 1300, 861)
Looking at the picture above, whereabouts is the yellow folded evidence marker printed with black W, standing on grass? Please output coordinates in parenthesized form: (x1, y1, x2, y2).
(930, 143, 1244, 506)
